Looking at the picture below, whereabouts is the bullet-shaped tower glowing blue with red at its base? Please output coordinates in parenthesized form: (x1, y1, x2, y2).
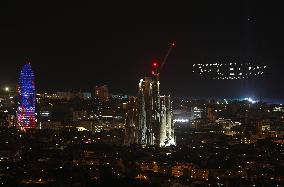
(17, 63, 36, 131)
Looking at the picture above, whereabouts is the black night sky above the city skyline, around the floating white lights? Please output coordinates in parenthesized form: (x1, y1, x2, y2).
(0, 0, 284, 99)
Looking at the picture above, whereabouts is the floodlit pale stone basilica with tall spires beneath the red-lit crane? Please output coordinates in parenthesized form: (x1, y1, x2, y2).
(125, 77, 175, 147)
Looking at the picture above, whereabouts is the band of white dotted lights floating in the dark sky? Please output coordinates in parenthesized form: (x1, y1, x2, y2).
(192, 63, 267, 80)
